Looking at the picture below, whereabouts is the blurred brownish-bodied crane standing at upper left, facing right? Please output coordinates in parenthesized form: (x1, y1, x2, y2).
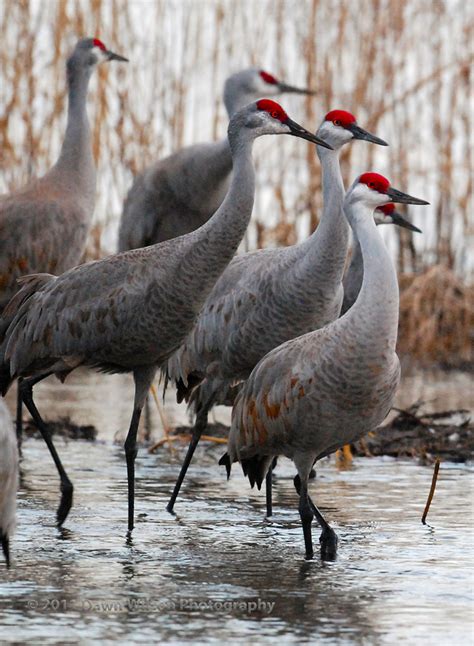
(0, 38, 127, 438)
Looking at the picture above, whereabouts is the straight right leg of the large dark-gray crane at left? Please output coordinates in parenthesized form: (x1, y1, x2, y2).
(124, 367, 156, 532)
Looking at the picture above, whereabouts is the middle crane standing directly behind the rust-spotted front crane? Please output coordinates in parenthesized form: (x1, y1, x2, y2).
(167, 110, 387, 515)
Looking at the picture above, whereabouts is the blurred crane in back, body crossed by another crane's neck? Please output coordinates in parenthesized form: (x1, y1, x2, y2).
(118, 67, 312, 251)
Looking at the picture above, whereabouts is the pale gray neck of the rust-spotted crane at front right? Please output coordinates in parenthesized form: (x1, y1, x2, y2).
(346, 203, 399, 351)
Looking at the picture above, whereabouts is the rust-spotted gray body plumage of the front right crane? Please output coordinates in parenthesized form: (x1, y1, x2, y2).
(229, 303, 400, 476)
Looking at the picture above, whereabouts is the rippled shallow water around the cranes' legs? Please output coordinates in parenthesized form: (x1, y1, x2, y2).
(0, 372, 474, 645)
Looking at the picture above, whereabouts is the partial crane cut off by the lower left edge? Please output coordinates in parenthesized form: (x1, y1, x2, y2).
(0, 400, 18, 567)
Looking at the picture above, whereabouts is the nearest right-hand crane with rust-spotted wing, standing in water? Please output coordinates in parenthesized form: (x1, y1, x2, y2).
(220, 173, 427, 560)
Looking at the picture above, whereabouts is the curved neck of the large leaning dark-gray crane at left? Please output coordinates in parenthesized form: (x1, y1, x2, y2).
(178, 140, 255, 293)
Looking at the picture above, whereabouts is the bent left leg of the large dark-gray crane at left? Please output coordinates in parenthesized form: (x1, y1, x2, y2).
(18, 373, 74, 527)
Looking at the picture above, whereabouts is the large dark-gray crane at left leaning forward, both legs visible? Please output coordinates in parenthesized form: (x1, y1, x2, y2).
(0, 99, 328, 531)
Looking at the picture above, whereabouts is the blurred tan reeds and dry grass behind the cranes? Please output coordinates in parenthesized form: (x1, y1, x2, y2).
(0, 0, 474, 364)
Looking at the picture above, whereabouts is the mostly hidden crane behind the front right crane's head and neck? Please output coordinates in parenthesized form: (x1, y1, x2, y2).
(341, 204, 421, 316)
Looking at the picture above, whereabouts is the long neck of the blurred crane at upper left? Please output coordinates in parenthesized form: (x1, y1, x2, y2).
(52, 62, 95, 195)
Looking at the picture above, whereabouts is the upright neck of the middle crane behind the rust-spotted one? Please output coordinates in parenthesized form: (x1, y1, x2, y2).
(288, 146, 349, 293)
